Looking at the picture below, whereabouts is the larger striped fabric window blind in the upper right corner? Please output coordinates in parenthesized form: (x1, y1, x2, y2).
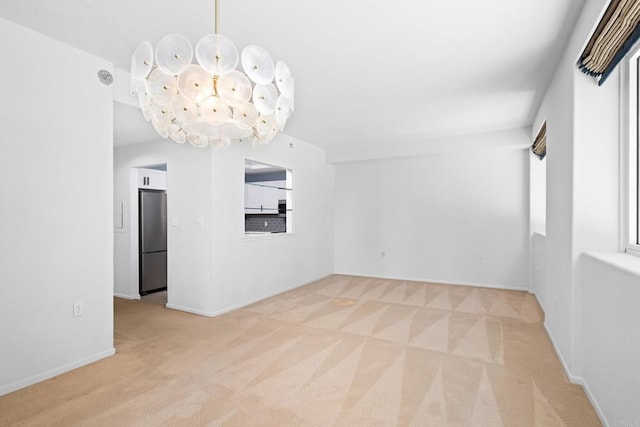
(578, 0, 640, 86)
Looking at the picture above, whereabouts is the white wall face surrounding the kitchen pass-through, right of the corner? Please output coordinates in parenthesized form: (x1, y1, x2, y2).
(211, 134, 334, 314)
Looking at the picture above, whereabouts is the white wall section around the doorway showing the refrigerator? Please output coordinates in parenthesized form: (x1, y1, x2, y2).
(114, 140, 212, 312)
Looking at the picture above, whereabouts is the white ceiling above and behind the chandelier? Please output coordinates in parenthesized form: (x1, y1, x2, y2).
(0, 0, 584, 149)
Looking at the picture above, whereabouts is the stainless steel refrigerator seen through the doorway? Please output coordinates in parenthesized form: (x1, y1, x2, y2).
(138, 190, 167, 295)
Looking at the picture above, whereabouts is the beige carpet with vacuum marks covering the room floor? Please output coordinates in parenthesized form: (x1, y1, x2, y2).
(0, 276, 600, 426)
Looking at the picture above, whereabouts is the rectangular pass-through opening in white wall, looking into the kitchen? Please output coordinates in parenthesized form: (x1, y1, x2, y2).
(244, 160, 293, 237)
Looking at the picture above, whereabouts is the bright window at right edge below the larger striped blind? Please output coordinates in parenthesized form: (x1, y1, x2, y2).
(621, 48, 640, 256)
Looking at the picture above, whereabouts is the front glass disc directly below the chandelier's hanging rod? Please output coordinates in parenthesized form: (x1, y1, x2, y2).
(196, 34, 238, 76)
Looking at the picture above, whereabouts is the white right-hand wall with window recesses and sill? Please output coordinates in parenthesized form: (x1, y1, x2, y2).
(532, 0, 640, 425)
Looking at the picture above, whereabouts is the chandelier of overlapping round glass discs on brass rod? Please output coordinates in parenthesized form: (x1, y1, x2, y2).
(131, 0, 294, 148)
